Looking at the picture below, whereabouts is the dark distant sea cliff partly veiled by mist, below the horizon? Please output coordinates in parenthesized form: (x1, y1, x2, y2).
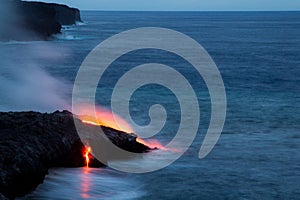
(0, 0, 81, 41)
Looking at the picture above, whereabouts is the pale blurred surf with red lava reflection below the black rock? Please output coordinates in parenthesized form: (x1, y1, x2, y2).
(26, 168, 144, 200)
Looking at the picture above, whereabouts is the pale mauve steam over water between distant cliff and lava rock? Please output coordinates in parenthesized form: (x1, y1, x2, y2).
(0, 42, 72, 112)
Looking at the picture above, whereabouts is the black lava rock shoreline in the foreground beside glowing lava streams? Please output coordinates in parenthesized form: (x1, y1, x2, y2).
(0, 111, 150, 199)
